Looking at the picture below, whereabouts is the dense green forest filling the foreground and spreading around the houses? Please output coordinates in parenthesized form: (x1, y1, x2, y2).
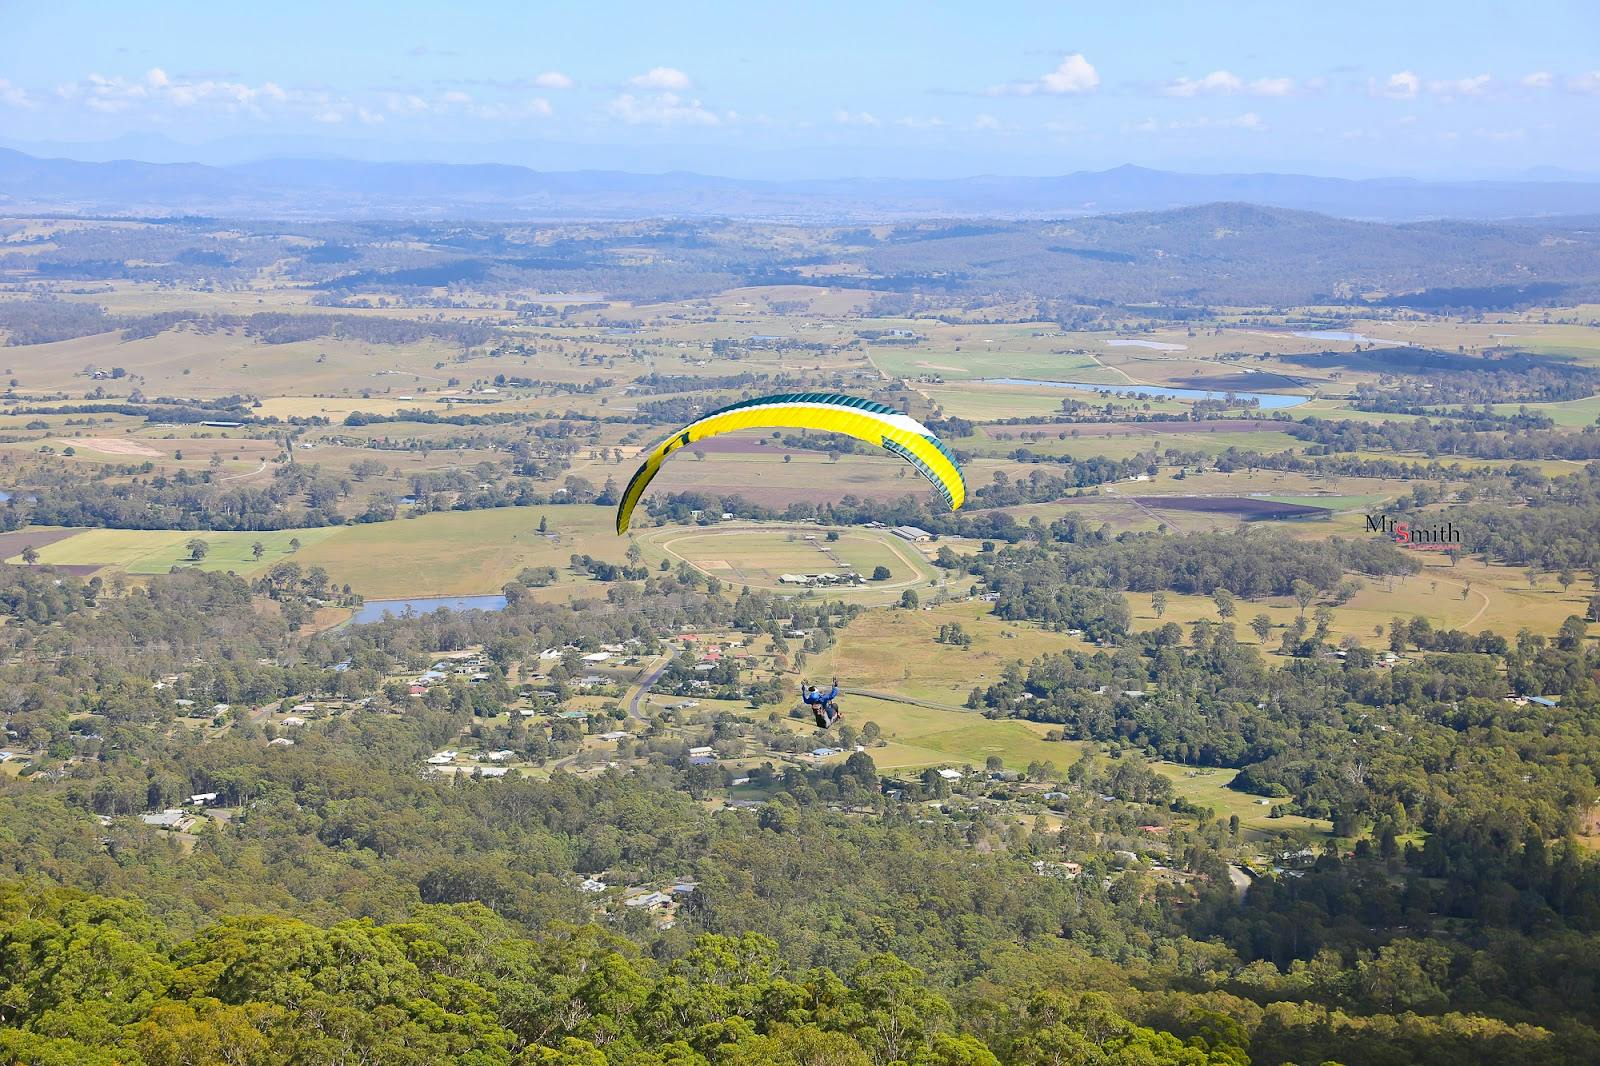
(0, 544, 1600, 1066)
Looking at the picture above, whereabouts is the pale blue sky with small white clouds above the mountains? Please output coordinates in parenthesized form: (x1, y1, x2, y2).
(0, 0, 1600, 178)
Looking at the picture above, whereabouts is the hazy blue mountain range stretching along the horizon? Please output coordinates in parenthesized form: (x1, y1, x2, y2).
(0, 149, 1600, 222)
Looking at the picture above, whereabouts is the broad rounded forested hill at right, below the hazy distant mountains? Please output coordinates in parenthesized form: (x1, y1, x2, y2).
(844, 203, 1600, 306)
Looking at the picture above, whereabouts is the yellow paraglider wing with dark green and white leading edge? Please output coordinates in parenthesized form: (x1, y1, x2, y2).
(616, 392, 966, 533)
